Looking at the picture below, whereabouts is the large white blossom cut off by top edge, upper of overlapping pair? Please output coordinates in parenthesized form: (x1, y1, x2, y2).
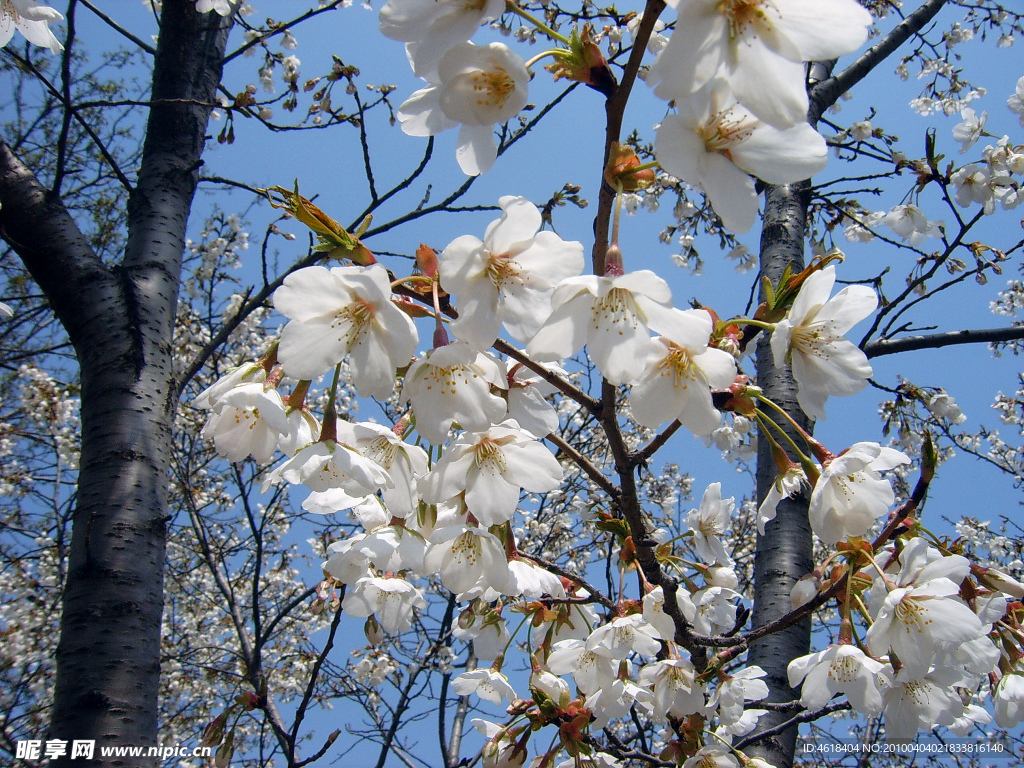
(647, 0, 871, 128)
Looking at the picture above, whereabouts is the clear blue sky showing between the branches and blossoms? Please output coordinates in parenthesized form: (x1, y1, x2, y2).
(61, 0, 1024, 765)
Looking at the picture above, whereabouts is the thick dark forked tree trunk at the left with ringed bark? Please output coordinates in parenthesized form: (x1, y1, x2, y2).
(0, 0, 230, 766)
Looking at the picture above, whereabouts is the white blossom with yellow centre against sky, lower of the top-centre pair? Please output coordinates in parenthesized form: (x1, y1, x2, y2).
(398, 43, 529, 176)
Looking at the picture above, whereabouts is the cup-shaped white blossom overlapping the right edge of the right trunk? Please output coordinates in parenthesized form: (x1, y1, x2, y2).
(808, 442, 910, 544)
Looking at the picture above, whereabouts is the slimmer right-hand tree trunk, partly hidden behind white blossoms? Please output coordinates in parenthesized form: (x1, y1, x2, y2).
(746, 181, 813, 768)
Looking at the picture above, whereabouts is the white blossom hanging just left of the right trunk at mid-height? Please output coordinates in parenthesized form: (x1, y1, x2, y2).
(630, 309, 736, 435)
